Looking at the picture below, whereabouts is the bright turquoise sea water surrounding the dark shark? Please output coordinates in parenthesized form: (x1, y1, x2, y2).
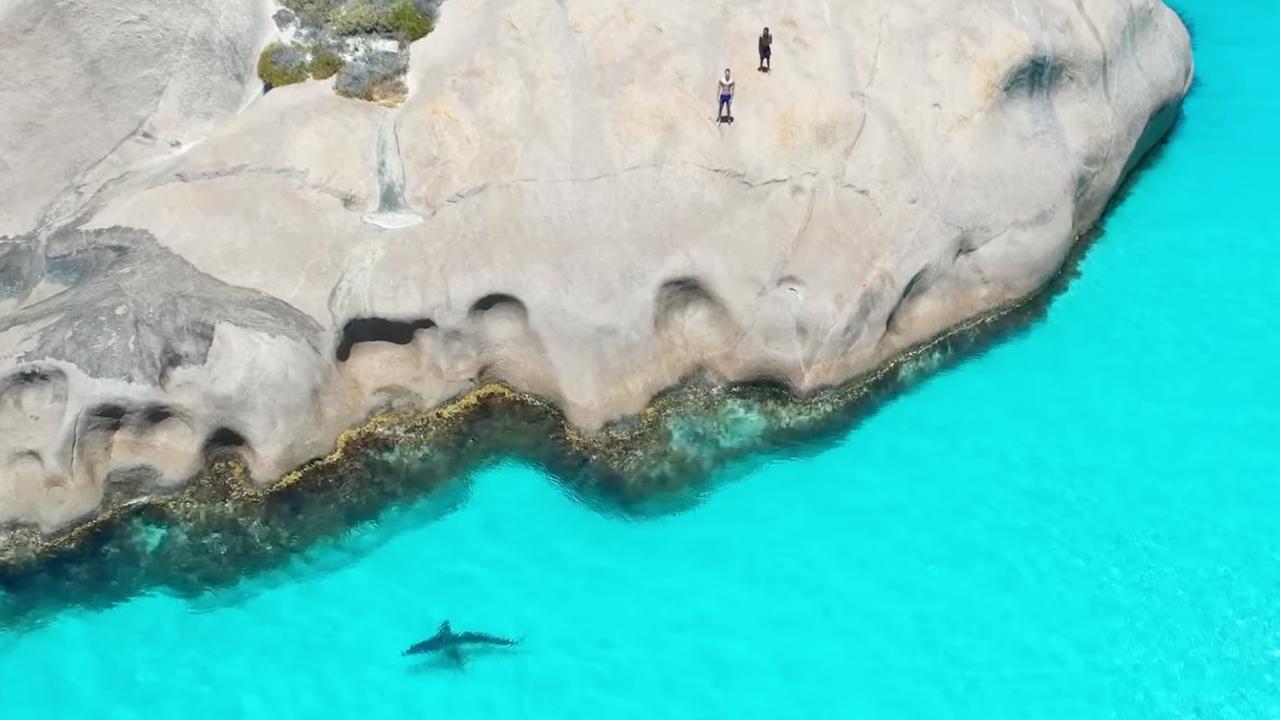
(0, 0, 1280, 720)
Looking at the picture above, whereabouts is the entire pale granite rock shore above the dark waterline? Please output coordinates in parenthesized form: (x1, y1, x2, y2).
(0, 0, 1192, 533)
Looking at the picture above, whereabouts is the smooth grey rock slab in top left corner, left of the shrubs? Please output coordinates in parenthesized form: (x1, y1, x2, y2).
(0, 0, 270, 237)
